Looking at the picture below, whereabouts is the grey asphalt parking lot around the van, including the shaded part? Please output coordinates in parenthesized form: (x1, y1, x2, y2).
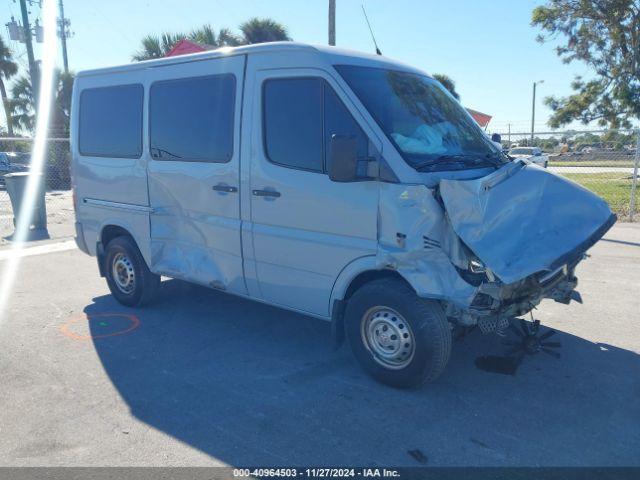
(0, 224, 640, 466)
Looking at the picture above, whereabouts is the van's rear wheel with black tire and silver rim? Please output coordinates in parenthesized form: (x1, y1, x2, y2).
(104, 236, 160, 307)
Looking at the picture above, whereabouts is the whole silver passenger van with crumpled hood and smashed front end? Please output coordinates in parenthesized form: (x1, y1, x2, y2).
(72, 42, 615, 386)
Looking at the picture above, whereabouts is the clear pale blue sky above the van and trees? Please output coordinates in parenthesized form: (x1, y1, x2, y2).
(0, 0, 589, 132)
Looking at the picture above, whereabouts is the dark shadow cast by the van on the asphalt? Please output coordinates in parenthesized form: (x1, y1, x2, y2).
(85, 280, 640, 466)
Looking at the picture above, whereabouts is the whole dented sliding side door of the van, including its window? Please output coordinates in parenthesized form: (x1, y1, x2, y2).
(147, 56, 246, 294)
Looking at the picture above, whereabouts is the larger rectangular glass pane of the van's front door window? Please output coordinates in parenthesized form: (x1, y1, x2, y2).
(263, 78, 323, 172)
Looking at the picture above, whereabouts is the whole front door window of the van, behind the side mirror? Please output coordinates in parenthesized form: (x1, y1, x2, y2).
(263, 77, 368, 172)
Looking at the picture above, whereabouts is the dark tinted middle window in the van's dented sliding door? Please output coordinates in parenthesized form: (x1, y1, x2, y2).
(149, 75, 235, 163)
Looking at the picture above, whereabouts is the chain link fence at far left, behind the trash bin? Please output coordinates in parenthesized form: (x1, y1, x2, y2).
(0, 137, 74, 245)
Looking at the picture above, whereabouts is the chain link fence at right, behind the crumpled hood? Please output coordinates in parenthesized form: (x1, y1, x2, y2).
(498, 130, 640, 221)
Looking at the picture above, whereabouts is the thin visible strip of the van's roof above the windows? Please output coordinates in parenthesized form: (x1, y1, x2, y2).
(77, 42, 424, 77)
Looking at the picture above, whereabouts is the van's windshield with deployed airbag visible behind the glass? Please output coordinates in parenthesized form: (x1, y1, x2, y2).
(336, 65, 507, 171)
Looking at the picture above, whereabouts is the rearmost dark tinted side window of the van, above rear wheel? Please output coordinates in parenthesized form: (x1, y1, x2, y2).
(78, 84, 144, 158)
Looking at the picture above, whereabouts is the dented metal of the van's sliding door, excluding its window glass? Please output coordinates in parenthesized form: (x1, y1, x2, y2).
(146, 56, 247, 295)
